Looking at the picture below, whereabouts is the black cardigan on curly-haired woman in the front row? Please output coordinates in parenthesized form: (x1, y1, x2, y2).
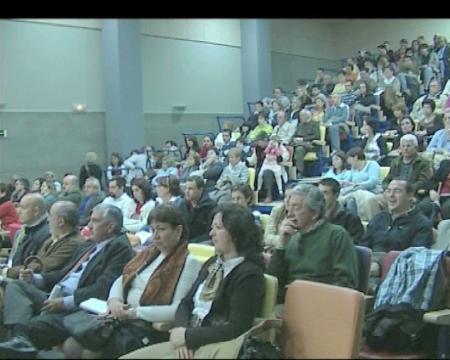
(175, 256, 265, 350)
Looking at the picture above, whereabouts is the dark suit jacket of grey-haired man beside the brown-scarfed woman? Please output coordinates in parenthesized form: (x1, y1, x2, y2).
(42, 234, 133, 305)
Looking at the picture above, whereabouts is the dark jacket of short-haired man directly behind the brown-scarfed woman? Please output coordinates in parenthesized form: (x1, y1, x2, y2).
(179, 190, 217, 243)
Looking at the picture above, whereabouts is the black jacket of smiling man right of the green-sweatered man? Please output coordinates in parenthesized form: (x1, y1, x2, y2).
(359, 208, 433, 252)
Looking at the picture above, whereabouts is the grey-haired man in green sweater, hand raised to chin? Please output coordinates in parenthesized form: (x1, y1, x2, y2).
(267, 184, 358, 303)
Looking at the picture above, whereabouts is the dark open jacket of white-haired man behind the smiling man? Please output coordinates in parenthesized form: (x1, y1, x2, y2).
(383, 155, 433, 190)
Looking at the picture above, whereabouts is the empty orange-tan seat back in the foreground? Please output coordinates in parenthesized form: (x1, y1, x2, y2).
(282, 280, 364, 359)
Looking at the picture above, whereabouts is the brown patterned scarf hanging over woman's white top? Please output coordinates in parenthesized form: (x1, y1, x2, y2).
(122, 241, 189, 305)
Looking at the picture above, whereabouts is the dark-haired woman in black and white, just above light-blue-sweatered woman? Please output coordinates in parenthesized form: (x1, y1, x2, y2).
(361, 117, 388, 164)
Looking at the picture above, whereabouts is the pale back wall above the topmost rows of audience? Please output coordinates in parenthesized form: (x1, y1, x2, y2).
(330, 19, 450, 58)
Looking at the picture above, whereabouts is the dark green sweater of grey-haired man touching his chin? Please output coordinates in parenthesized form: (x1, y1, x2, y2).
(267, 222, 358, 301)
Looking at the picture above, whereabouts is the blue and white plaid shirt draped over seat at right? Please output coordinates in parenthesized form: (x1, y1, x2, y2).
(374, 246, 445, 311)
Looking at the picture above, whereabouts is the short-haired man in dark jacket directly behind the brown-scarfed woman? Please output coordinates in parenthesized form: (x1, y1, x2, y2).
(178, 175, 216, 243)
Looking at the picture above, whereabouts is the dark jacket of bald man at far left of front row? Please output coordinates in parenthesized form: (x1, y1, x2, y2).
(12, 217, 50, 266)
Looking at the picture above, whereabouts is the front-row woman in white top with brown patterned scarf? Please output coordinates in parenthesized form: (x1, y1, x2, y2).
(63, 205, 201, 359)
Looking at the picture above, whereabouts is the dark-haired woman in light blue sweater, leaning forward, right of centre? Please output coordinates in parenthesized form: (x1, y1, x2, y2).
(339, 148, 381, 220)
